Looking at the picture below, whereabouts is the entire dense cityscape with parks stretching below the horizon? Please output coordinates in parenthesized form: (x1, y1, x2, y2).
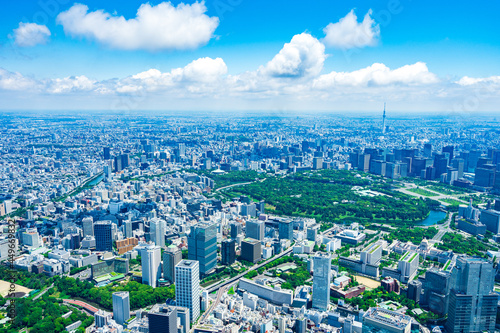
(0, 110, 500, 333)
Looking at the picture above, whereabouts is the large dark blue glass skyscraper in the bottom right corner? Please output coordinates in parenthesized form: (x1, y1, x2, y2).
(445, 256, 498, 333)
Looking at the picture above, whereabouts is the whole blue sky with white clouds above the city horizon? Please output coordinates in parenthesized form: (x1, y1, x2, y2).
(0, 0, 500, 112)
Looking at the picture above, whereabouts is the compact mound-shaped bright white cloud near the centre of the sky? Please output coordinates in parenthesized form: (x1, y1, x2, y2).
(261, 33, 326, 78)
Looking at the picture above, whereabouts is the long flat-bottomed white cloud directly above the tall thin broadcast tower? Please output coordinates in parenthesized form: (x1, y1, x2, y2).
(313, 62, 439, 89)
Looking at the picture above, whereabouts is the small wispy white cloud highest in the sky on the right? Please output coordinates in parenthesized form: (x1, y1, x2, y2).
(323, 9, 380, 49)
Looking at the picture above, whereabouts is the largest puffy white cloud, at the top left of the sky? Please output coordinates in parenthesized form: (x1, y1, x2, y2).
(57, 2, 219, 51)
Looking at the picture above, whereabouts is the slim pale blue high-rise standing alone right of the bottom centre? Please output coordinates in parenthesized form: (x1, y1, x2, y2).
(312, 255, 332, 311)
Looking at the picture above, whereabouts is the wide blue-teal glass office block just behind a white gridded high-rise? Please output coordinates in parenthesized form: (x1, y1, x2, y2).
(188, 223, 217, 275)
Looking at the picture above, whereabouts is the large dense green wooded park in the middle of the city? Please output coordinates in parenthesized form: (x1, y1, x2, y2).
(234, 170, 430, 221)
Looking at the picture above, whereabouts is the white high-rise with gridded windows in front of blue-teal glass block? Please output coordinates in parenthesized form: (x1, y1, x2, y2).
(175, 260, 200, 322)
